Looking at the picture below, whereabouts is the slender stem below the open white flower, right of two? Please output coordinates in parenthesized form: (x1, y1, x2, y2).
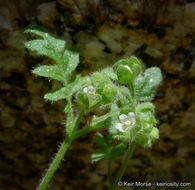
(113, 141, 136, 190)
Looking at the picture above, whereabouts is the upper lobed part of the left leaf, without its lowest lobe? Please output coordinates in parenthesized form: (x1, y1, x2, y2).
(25, 29, 79, 82)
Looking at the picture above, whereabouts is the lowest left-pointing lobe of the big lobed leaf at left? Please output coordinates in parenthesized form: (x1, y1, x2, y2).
(44, 88, 67, 101)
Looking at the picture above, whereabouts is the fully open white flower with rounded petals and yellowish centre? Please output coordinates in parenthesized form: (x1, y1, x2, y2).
(115, 112, 136, 132)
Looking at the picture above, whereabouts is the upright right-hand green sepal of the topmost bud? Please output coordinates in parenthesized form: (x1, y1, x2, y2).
(129, 56, 142, 78)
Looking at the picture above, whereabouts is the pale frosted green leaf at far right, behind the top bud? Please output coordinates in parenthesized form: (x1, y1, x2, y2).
(134, 67, 162, 102)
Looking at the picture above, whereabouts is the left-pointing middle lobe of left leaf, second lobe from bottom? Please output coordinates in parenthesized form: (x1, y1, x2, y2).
(32, 65, 65, 82)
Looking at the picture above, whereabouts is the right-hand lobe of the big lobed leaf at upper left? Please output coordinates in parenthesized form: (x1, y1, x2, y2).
(60, 49, 79, 78)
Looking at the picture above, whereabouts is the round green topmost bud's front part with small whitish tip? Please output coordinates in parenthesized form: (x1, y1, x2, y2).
(116, 65, 134, 84)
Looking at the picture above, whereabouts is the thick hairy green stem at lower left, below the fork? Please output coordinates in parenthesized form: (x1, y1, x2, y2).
(37, 140, 71, 190)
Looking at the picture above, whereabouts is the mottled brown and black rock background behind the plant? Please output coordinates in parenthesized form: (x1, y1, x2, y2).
(0, 0, 195, 190)
